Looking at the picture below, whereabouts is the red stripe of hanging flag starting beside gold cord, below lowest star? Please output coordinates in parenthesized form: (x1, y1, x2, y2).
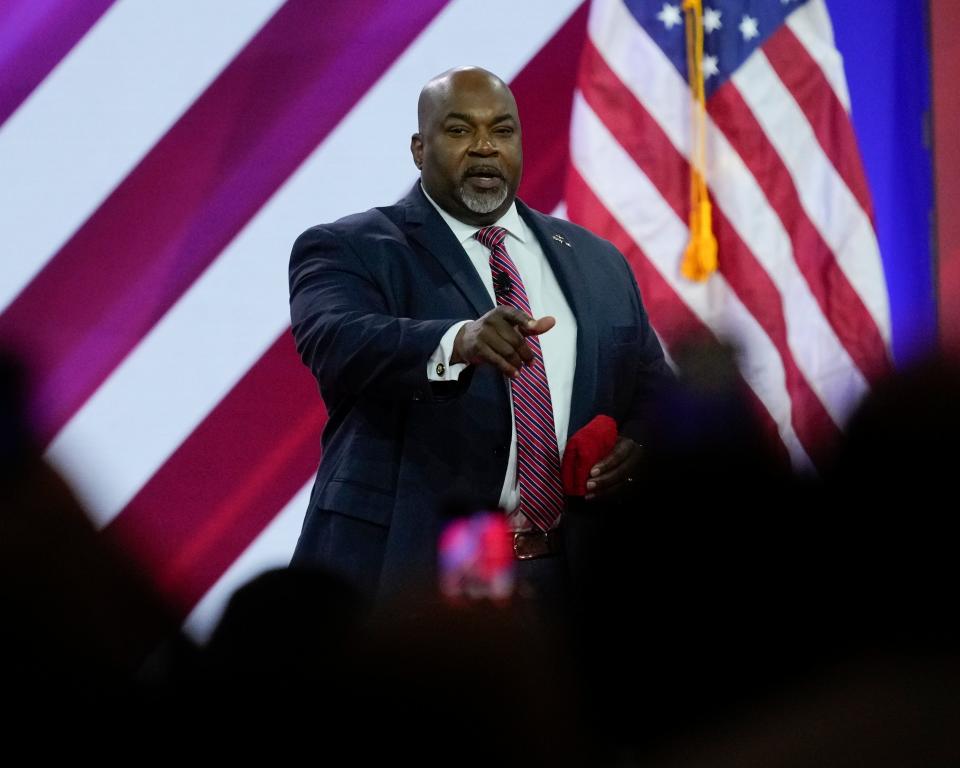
(709, 80, 890, 381)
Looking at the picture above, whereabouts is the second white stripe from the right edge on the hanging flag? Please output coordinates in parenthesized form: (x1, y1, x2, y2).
(733, 49, 890, 345)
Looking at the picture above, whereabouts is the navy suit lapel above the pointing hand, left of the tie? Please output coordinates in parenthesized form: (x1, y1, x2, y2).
(403, 182, 493, 317)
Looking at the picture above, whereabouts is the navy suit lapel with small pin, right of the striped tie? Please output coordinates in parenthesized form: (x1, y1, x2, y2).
(517, 200, 599, 437)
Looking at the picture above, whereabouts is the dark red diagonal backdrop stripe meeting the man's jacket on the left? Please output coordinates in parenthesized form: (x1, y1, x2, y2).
(106, 334, 326, 615)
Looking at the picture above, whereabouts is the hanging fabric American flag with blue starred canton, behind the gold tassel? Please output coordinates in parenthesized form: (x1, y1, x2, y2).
(566, 0, 890, 466)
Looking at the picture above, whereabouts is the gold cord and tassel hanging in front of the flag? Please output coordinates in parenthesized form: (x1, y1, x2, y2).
(680, 0, 717, 282)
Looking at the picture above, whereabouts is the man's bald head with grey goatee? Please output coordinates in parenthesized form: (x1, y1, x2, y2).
(410, 67, 523, 226)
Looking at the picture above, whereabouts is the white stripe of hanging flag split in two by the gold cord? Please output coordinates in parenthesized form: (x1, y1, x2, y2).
(590, 3, 867, 424)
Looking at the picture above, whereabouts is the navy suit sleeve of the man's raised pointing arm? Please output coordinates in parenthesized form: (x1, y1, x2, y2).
(290, 222, 469, 400)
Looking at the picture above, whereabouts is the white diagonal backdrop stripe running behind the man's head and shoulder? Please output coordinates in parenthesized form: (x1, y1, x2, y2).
(48, 0, 579, 525)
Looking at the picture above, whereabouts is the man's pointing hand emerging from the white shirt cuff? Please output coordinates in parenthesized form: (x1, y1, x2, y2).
(450, 306, 557, 379)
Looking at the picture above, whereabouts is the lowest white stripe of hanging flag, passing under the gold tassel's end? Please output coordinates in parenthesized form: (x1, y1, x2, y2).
(571, 93, 810, 467)
